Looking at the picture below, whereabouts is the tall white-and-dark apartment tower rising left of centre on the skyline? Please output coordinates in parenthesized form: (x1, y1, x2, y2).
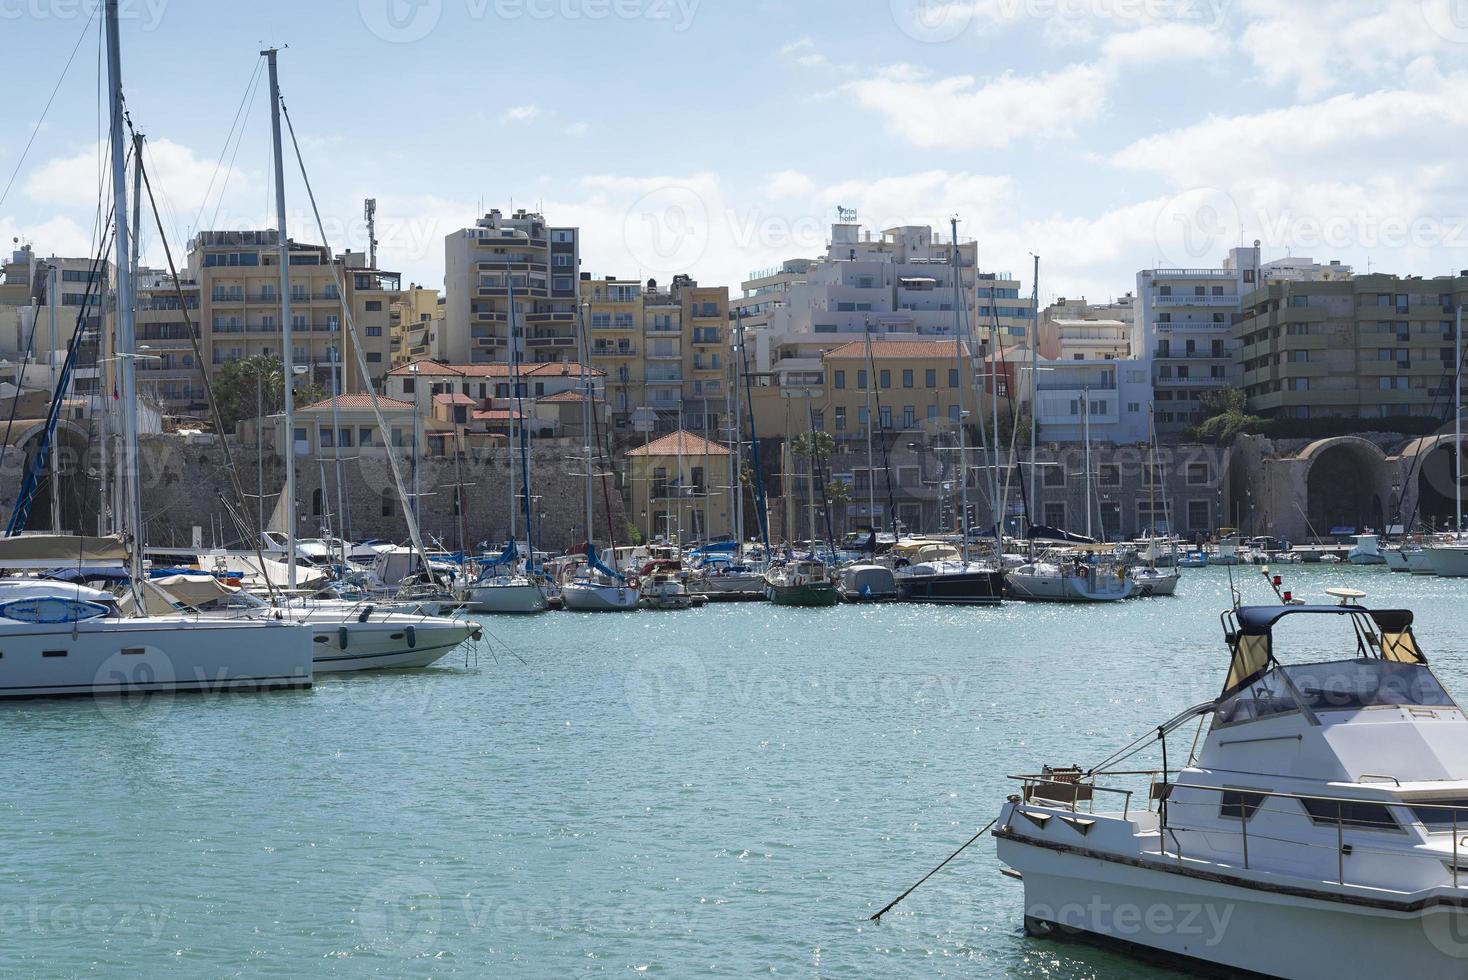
(440, 210, 581, 364)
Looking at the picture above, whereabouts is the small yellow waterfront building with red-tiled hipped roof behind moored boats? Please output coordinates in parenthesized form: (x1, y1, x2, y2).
(627, 428, 734, 543)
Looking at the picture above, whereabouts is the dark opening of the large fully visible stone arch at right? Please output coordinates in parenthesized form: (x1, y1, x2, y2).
(1299, 436, 1387, 537)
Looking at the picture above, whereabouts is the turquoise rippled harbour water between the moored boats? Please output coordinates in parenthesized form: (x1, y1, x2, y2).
(0, 566, 1468, 977)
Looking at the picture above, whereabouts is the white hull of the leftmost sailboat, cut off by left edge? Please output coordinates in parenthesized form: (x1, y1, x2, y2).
(0, 616, 313, 698)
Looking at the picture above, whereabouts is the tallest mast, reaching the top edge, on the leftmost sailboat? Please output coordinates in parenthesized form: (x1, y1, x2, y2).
(104, 0, 144, 613)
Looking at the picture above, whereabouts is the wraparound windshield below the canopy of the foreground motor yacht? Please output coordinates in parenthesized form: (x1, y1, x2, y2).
(1217, 659, 1453, 725)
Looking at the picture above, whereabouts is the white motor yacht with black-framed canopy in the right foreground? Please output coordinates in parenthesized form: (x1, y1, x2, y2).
(994, 590, 1468, 980)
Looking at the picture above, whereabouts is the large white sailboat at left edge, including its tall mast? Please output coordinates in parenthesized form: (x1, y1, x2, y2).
(0, 0, 313, 698)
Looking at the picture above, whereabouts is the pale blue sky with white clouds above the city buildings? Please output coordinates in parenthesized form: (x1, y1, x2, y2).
(0, 0, 1468, 301)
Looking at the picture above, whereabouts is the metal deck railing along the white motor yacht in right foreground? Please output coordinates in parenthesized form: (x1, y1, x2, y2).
(1010, 770, 1468, 888)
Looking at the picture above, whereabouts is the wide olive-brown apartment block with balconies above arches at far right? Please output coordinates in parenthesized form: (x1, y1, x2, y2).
(1230, 270, 1468, 418)
